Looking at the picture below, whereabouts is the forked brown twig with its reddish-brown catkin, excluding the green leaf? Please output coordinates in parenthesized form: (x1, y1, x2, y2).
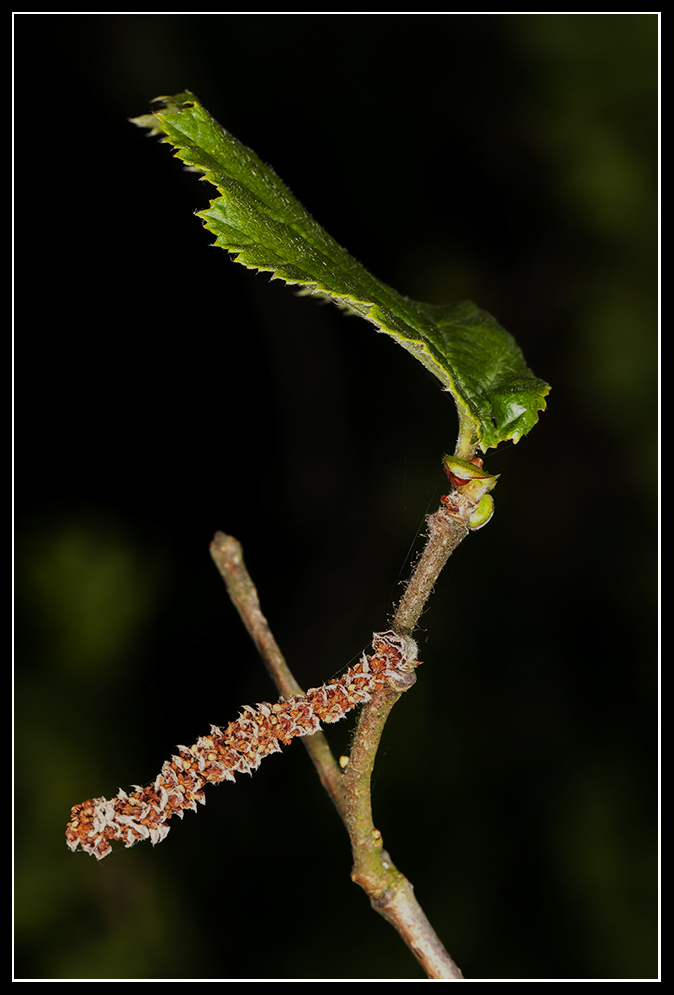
(66, 474, 470, 980)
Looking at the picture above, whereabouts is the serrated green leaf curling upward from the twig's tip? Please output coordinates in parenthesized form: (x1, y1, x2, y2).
(133, 92, 550, 459)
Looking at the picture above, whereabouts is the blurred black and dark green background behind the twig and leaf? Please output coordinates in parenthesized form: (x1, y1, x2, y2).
(15, 14, 658, 980)
